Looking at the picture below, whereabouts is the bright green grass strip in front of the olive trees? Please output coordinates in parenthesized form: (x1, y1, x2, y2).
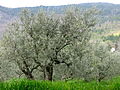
(0, 77, 120, 90)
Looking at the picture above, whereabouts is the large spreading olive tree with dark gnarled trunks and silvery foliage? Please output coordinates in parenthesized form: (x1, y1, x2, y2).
(3, 9, 96, 81)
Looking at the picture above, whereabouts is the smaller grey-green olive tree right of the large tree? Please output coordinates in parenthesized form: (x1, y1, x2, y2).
(88, 41, 116, 82)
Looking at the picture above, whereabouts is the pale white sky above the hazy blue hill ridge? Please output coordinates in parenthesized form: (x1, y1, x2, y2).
(0, 0, 120, 8)
